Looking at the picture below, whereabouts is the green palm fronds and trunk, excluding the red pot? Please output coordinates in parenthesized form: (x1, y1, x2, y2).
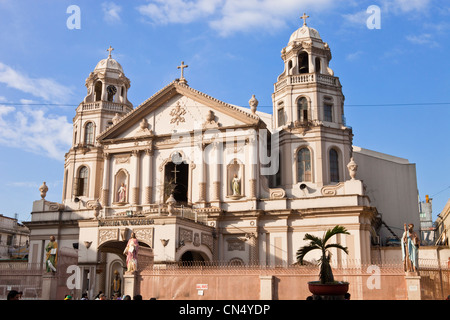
(297, 225, 350, 284)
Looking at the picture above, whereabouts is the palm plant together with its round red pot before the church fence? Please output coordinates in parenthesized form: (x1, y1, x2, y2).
(297, 225, 350, 296)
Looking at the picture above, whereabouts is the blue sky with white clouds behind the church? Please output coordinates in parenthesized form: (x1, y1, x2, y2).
(0, 0, 450, 221)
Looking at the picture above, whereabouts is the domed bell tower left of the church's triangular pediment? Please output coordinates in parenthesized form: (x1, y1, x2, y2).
(63, 46, 133, 207)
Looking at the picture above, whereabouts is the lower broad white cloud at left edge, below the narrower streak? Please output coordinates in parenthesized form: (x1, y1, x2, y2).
(0, 105, 72, 160)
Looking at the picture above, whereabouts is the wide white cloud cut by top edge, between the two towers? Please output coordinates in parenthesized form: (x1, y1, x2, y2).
(137, 0, 338, 36)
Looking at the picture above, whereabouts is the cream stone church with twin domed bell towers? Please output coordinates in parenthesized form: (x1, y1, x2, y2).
(27, 16, 419, 298)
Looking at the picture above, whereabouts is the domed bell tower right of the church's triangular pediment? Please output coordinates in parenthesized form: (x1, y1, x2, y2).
(272, 14, 353, 189)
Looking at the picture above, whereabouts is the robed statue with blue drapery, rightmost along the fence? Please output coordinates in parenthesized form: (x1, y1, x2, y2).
(402, 223, 420, 272)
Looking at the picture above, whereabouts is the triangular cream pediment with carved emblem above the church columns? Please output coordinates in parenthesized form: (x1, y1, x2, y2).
(98, 81, 263, 141)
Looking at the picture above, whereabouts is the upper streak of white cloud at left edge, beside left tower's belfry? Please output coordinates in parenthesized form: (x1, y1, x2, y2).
(0, 62, 72, 103)
